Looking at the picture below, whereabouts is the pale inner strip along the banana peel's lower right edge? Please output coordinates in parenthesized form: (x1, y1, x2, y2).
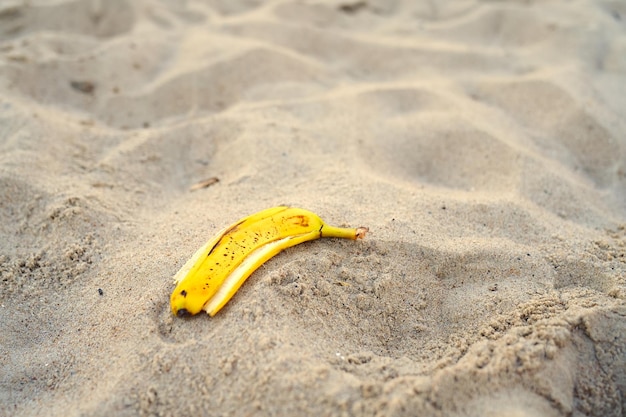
(202, 236, 299, 315)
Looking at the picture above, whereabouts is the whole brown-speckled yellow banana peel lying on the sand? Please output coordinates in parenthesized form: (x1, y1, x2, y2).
(170, 206, 368, 317)
